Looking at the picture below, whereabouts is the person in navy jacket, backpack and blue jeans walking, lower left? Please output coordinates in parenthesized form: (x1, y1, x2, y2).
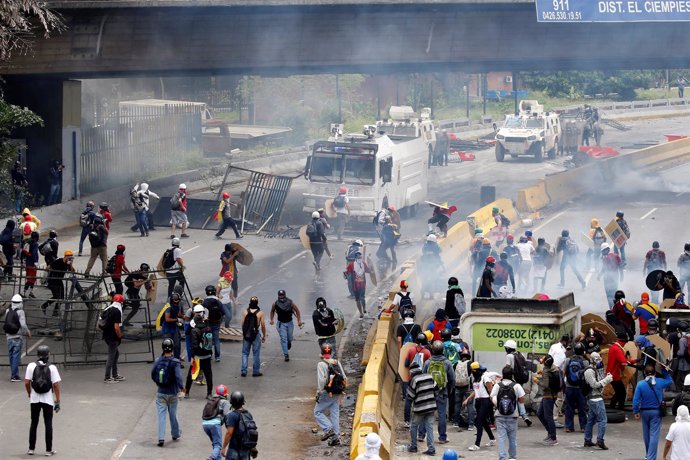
(151, 338, 184, 447)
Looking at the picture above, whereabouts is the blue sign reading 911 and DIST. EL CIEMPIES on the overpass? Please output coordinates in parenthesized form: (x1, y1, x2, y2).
(536, 0, 690, 22)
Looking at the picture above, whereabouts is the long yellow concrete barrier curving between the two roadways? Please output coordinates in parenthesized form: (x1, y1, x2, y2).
(350, 131, 690, 460)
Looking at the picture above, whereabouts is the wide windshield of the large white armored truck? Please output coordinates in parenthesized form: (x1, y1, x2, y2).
(309, 142, 377, 185)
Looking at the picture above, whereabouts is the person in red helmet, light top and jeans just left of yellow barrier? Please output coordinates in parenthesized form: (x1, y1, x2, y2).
(314, 343, 347, 446)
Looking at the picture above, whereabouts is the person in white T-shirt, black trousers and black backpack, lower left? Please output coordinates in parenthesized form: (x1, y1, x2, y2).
(24, 345, 61, 457)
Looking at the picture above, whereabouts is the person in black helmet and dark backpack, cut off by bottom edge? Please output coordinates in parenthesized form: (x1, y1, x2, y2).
(220, 391, 259, 460)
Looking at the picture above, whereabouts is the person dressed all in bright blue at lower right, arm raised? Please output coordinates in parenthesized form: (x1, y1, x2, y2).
(633, 363, 673, 460)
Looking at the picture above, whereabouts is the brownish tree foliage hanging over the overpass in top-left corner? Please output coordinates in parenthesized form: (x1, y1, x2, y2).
(0, 0, 64, 61)
